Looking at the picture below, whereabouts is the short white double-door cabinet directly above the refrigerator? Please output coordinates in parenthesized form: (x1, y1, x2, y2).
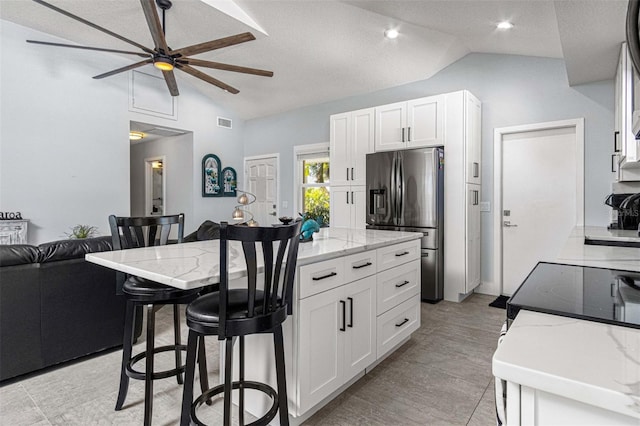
(374, 95, 444, 151)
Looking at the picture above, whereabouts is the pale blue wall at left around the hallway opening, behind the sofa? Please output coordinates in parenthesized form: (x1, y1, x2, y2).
(0, 21, 248, 244)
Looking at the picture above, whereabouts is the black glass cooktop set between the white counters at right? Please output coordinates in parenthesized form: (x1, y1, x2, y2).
(507, 262, 640, 328)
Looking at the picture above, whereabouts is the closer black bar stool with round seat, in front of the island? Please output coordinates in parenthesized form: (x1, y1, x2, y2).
(181, 222, 302, 426)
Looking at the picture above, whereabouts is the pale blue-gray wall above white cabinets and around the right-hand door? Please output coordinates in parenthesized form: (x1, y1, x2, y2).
(245, 54, 614, 292)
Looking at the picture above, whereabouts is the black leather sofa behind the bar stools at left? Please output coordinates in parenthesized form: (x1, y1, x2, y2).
(0, 237, 125, 380)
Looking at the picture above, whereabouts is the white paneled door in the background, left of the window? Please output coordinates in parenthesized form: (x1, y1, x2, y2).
(244, 155, 278, 226)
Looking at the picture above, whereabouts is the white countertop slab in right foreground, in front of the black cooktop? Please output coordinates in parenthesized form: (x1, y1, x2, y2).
(493, 310, 640, 419)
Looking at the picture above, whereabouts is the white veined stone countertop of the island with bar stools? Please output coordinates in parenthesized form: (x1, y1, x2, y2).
(85, 228, 422, 289)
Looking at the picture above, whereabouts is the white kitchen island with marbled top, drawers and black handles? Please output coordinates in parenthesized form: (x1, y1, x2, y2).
(86, 228, 422, 424)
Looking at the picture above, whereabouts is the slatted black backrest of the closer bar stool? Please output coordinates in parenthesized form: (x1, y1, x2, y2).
(218, 221, 302, 340)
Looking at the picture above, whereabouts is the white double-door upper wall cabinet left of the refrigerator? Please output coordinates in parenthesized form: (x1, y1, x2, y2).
(329, 108, 374, 186)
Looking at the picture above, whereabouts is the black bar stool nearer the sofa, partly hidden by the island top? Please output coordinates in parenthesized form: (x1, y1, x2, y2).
(109, 213, 209, 426)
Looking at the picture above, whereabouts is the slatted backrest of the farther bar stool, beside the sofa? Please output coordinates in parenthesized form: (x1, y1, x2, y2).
(109, 213, 184, 250)
